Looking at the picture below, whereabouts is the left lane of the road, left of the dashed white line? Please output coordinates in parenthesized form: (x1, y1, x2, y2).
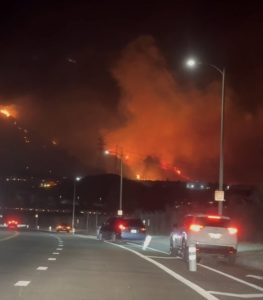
(0, 230, 58, 300)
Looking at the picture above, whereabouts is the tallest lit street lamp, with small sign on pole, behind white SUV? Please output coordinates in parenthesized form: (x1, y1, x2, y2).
(186, 59, 226, 215)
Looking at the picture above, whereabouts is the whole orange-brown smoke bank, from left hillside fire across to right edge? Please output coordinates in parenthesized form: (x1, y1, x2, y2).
(3, 36, 263, 183)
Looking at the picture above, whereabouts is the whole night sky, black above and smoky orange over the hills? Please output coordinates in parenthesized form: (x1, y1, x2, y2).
(0, 1, 263, 183)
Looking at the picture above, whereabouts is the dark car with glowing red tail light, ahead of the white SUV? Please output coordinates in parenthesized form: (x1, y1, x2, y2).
(97, 217, 146, 241)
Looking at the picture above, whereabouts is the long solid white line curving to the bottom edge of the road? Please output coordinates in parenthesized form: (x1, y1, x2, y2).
(105, 241, 219, 300)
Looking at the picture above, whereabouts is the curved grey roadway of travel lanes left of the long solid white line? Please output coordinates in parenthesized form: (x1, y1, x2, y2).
(0, 233, 209, 300)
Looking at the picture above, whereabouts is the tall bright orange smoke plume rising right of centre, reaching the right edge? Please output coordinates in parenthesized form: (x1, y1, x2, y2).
(103, 37, 262, 182)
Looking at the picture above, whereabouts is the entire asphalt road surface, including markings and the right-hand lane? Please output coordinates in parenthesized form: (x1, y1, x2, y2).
(0, 231, 263, 300)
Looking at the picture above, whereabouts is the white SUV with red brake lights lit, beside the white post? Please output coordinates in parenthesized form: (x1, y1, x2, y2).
(170, 214, 237, 263)
